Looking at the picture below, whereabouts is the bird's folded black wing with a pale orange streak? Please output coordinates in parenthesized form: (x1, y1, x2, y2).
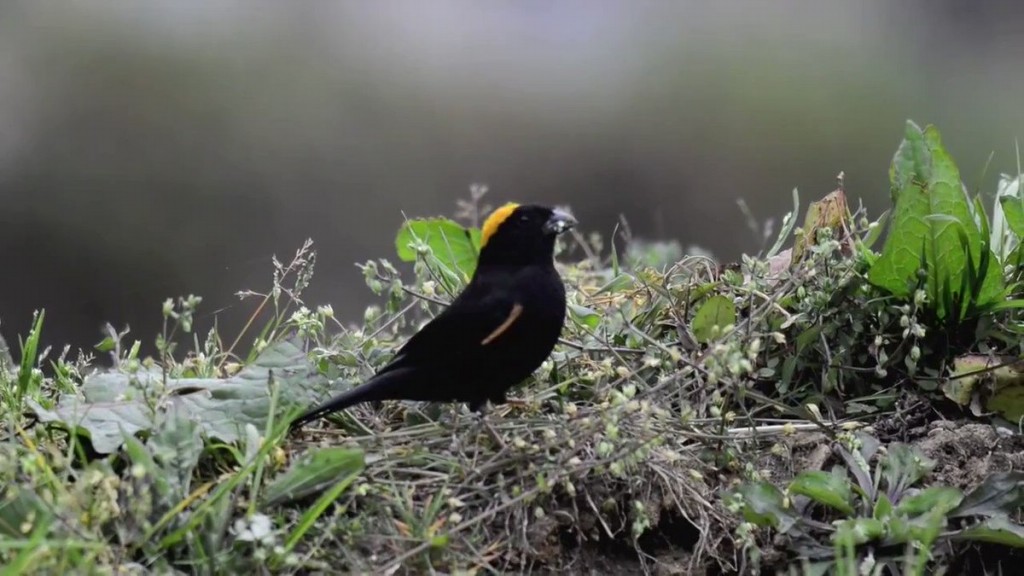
(386, 286, 523, 370)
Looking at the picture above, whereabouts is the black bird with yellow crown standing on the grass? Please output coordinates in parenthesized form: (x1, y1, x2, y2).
(291, 203, 577, 429)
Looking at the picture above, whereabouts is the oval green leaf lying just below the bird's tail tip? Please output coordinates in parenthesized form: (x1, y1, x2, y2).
(263, 447, 366, 506)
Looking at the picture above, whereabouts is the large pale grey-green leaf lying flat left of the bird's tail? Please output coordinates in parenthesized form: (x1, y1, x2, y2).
(30, 340, 326, 453)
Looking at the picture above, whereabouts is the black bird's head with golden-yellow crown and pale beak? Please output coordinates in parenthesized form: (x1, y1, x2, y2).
(480, 202, 577, 265)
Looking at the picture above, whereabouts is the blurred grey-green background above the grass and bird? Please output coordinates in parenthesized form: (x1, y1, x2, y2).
(0, 0, 1024, 354)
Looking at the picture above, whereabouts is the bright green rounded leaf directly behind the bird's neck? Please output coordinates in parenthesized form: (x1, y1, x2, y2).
(394, 218, 480, 281)
